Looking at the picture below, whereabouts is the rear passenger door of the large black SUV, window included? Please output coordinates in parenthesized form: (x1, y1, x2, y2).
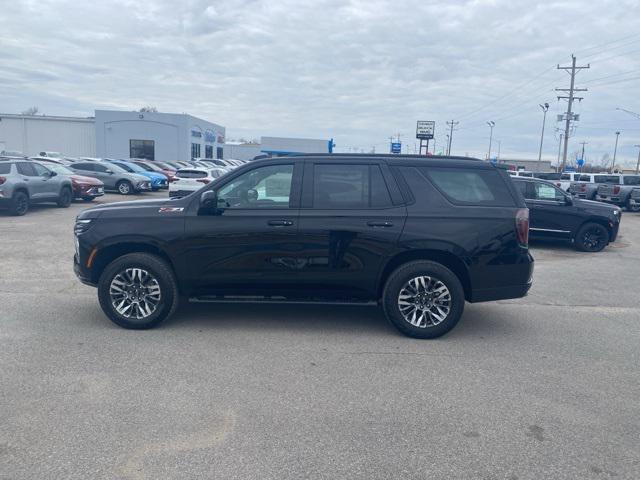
(299, 159, 406, 298)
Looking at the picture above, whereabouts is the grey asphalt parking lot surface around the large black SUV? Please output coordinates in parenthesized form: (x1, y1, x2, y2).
(0, 193, 640, 480)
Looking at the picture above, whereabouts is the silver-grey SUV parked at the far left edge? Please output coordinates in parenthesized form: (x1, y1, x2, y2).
(0, 160, 73, 215)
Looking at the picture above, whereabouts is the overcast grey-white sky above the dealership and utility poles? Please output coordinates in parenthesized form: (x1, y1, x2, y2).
(0, 0, 640, 164)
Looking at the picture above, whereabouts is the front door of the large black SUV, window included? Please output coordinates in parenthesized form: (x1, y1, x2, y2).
(180, 161, 302, 295)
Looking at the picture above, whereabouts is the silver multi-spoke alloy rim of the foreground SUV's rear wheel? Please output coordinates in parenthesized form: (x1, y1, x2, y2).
(398, 276, 451, 328)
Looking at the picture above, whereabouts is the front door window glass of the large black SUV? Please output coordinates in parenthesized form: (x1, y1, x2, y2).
(218, 164, 293, 208)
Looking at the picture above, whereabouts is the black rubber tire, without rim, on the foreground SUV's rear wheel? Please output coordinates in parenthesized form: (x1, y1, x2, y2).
(382, 260, 465, 338)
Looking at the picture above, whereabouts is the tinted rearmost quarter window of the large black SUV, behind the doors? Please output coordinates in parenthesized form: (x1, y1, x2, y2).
(420, 167, 515, 207)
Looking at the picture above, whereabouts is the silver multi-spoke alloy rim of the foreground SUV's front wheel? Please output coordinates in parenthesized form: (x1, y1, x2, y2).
(109, 268, 162, 320)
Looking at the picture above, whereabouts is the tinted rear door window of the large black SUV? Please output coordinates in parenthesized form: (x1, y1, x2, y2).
(313, 164, 391, 209)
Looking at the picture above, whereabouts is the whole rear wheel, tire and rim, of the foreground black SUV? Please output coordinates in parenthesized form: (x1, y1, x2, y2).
(382, 260, 464, 338)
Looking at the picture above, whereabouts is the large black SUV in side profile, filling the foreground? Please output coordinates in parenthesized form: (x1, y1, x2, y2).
(75, 155, 533, 338)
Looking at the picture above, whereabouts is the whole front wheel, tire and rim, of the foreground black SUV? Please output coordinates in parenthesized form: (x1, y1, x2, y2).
(98, 253, 179, 329)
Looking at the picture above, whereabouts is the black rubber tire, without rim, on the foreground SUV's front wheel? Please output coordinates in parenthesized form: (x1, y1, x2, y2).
(98, 253, 180, 330)
